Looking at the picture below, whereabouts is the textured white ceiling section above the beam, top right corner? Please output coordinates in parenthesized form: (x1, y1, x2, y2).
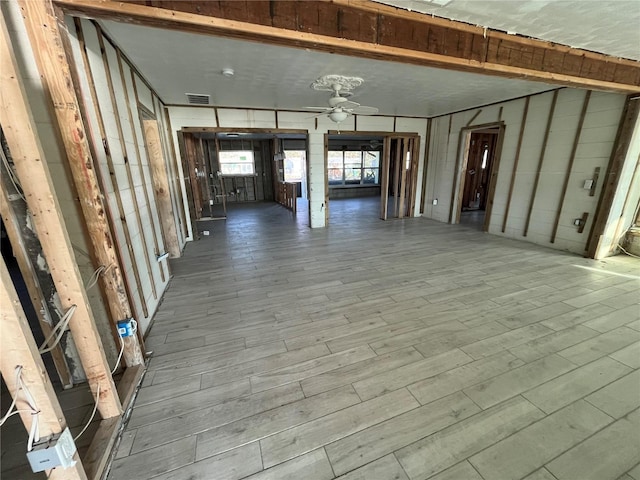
(375, 0, 640, 60)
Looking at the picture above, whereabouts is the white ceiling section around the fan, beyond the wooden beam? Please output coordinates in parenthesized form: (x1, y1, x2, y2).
(101, 21, 555, 117)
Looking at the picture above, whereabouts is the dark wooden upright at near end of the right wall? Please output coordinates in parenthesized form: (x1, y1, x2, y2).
(585, 98, 640, 258)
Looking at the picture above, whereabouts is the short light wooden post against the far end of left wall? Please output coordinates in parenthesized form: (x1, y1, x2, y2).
(142, 118, 182, 258)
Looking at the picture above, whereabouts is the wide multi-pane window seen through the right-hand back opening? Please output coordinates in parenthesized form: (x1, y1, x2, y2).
(327, 150, 380, 185)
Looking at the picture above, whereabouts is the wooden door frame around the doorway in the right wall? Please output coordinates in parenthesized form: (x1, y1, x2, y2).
(449, 121, 506, 232)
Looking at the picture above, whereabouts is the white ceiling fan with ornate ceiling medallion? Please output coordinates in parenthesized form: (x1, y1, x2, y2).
(304, 75, 378, 123)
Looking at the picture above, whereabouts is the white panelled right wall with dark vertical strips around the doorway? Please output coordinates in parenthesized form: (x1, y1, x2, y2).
(424, 88, 625, 254)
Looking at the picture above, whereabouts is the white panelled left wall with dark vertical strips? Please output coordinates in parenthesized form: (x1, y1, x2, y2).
(67, 18, 170, 333)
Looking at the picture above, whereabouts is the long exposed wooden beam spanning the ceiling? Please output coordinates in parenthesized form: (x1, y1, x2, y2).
(56, 0, 640, 93)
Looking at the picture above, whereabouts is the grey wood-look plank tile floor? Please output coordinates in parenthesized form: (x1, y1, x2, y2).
(109, 199, 640, 480)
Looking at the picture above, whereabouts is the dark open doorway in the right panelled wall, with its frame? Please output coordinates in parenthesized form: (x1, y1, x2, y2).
(452, 124, 504, 231)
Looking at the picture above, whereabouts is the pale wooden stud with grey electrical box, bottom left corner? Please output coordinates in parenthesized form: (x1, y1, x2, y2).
(0, 258, 86, 480)
